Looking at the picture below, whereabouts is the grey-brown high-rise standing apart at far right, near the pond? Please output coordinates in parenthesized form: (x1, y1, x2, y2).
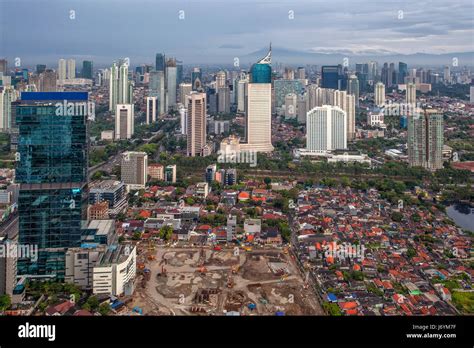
(408, 109, 444, 170)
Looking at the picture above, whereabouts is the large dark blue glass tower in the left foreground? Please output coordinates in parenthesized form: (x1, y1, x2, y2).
(16, 92, 88, 280)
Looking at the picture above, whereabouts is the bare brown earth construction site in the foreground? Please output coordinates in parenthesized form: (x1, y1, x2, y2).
(128, 246, 324, 316)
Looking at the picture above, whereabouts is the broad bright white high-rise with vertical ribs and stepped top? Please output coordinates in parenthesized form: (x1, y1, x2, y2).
(306, 105, 347, 152)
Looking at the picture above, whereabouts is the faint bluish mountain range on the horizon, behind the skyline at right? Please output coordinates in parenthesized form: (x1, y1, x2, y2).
(240, 47, 474, 66)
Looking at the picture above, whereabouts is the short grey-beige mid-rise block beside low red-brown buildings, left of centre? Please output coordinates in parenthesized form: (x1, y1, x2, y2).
(120, 151, 148, 190)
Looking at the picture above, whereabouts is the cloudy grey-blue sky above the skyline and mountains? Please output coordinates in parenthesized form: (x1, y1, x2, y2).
(0, 0, 474, 64)
